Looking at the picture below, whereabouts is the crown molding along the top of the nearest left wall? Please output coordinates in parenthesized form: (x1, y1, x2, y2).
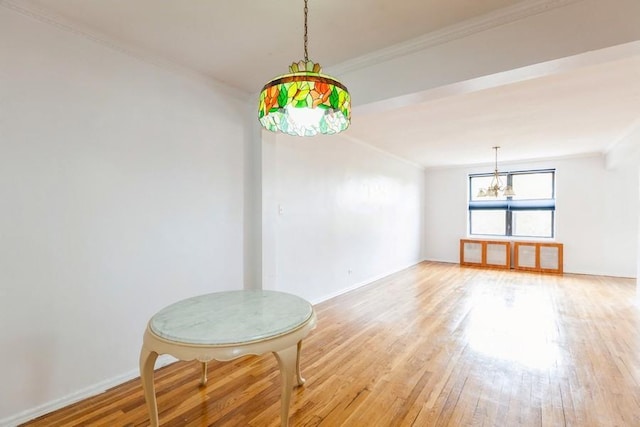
(0, 0, 253, 102)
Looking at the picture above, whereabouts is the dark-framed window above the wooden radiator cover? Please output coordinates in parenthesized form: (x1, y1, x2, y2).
(469, 169, 556, 237)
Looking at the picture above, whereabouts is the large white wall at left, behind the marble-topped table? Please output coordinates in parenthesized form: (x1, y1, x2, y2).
(0, 7, 246, 425)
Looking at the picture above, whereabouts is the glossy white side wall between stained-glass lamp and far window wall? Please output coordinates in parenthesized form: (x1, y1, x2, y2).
(263, 135, 424, 301)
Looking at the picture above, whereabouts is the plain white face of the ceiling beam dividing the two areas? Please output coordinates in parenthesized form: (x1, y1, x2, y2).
(336, 0, 640, 107)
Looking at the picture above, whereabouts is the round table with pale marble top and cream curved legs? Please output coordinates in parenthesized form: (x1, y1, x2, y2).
(140, 290, 316, 427)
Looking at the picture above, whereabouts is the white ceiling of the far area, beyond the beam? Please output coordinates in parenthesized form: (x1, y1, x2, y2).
(349, 56, 640, 167)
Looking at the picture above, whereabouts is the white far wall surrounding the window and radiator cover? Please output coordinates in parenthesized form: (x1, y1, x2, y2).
(425, 156, 639, 277)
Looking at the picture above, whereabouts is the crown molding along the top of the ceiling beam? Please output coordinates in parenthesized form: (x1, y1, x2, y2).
(326, 0, 584, 75)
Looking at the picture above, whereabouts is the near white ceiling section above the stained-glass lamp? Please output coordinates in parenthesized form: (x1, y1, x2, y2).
(20, 0, 518, 93)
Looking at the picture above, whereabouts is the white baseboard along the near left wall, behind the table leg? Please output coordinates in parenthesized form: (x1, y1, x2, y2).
(0, 354, 177, 427)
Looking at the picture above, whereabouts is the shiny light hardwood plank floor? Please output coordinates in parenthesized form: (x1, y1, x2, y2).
(21, 262, 640, 427)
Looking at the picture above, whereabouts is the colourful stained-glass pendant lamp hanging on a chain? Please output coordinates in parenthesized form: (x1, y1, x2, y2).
(258, 0, 351, 136)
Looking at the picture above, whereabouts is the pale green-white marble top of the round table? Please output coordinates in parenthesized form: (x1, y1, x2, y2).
(149, 290, 313, 345)
